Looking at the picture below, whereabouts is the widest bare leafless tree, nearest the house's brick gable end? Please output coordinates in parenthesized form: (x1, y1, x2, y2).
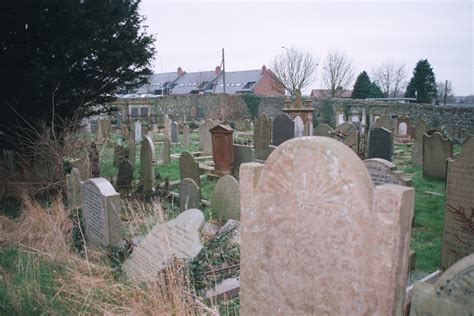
(271, 47, 318, 95)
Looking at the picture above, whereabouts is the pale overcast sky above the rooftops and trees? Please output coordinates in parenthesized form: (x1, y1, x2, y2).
(140, 0, 474, 96)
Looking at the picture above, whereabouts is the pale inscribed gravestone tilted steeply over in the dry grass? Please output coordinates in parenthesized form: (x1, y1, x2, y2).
(123, 209, 204, 282)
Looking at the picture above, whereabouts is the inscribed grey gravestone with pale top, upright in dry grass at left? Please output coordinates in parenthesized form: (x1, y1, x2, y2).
(82, 178, 122, 246)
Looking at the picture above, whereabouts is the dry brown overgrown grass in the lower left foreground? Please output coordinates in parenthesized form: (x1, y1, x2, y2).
(0, 196, 218, 315)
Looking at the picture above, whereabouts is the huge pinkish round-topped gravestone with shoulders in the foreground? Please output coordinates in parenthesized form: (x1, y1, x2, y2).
(240, 137, 414, 315)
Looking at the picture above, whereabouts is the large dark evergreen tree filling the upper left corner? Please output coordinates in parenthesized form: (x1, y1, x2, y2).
(0, 0, 154, 146)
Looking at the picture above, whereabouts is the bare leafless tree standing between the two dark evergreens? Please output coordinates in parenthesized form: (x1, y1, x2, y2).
(372, 60, 408, 98)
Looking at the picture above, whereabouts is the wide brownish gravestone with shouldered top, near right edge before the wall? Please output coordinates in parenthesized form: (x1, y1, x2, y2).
(422, 132, 453, 180)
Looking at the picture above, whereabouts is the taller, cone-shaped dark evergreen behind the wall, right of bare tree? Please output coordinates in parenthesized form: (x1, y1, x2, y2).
(405, 59, 438, 103)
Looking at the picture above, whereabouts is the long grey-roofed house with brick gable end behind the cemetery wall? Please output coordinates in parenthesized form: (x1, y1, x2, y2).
(130, 65, 285, 96)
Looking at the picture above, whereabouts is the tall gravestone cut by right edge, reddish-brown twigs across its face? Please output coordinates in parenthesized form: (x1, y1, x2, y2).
(441, 138, 474, 269)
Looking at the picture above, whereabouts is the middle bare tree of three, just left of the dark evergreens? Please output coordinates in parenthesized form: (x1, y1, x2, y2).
(323, 51, 354, 97)
